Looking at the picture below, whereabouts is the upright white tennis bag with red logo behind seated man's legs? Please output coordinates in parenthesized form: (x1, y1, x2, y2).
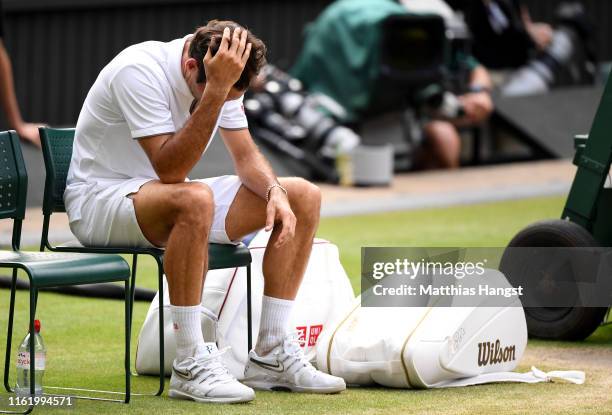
(136, 231, 355, 379)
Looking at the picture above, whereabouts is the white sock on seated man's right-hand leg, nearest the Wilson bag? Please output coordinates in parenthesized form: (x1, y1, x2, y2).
(255, 295, 294, 356)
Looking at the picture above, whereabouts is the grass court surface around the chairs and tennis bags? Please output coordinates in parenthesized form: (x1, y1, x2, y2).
(0, 198, 612, 415)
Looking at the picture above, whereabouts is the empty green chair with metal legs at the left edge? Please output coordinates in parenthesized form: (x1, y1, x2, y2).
(0, 131, 132, 413)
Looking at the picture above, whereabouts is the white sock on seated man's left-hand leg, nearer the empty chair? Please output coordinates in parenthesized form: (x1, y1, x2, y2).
(170, 305, 204, 362)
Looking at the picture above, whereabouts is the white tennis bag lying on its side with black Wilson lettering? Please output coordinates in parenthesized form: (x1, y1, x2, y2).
(317, 270, 584, 389)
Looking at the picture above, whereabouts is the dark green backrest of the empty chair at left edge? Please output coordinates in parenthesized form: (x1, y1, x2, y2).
(0, 131, 28, 220)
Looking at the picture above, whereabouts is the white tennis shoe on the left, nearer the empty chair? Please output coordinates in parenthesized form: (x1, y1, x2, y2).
(168, 343, 255, 403)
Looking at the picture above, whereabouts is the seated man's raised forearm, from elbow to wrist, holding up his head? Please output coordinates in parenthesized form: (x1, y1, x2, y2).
(152, 86, 227, 183)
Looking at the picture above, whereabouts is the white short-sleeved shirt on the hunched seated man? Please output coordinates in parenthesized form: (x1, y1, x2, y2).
(64, 35, 248, 222)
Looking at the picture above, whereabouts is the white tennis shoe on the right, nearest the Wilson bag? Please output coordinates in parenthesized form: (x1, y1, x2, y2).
(243, 332, 346, 393)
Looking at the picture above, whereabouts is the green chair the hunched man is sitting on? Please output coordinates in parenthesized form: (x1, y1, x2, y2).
(39, 127, 252, 395)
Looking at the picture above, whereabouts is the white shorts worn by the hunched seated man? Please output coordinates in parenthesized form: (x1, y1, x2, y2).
(70, 176, 242, 248)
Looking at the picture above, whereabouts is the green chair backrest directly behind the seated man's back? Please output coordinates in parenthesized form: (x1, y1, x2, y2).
(39, 127, 74, 215)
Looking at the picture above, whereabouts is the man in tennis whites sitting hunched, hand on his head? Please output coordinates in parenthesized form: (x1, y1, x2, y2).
(64, 21, 345, 402)
